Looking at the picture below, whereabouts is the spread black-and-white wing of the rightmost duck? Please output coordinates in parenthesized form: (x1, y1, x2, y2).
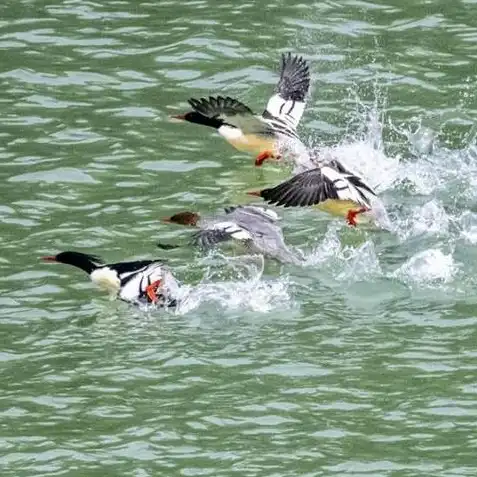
(253, 165, 375, 207)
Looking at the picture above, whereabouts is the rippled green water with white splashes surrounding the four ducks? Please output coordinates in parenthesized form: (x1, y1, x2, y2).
(0, 0, 477, 477)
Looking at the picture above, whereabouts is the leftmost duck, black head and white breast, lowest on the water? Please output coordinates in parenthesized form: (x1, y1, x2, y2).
(42, 251, 179, 307)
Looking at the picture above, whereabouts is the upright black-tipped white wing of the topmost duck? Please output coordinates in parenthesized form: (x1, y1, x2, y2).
(263, 53, 310, 129)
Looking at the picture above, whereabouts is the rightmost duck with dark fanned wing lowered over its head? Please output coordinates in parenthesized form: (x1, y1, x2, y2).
(248, 159, 376, 226)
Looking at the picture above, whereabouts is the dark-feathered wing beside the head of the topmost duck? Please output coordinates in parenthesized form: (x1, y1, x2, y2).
(188, 96, 271, 134)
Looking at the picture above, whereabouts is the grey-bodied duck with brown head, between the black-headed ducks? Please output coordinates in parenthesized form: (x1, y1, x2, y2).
(158, 205, 302, 264)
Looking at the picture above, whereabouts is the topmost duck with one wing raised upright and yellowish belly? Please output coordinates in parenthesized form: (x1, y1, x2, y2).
(173, 53, 310, 166)
